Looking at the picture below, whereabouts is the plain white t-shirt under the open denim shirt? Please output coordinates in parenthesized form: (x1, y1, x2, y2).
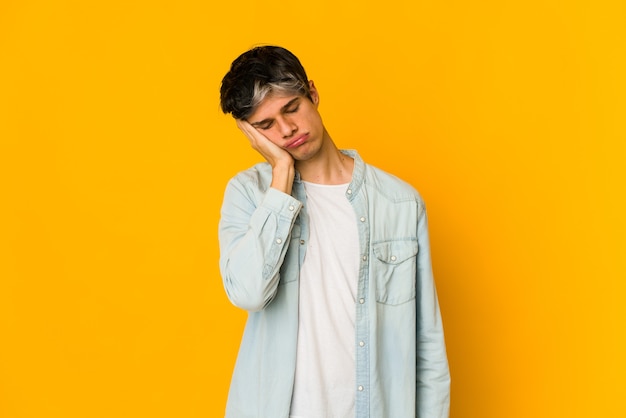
(290, 182, 359, 418)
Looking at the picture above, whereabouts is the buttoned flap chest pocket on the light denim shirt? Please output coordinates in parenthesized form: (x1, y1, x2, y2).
(370, 239, 418, 305)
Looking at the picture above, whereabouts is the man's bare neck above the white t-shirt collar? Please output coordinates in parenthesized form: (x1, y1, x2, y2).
(295, 131, 354, 184)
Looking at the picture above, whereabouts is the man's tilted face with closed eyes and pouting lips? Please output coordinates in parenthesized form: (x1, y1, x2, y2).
(247, 82, 325, 161)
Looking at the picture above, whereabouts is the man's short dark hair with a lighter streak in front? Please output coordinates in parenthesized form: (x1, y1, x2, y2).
(220, 45, 311, 119)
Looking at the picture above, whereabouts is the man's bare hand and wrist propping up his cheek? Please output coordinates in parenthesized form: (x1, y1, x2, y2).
(237, 119, 296, 194)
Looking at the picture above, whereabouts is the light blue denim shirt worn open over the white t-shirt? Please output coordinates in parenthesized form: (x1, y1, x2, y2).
(219, 151, 450, 418)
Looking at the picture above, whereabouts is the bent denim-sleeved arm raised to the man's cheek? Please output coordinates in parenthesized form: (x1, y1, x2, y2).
(219, 177, 302, 311)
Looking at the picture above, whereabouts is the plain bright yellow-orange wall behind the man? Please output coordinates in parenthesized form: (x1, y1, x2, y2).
(0, 0, 626, 418)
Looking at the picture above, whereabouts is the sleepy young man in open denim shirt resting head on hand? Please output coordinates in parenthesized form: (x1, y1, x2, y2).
(219, 46, 450, 418)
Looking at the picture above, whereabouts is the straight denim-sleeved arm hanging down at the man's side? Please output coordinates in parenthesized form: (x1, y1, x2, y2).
(415, 202, 450, 418)
